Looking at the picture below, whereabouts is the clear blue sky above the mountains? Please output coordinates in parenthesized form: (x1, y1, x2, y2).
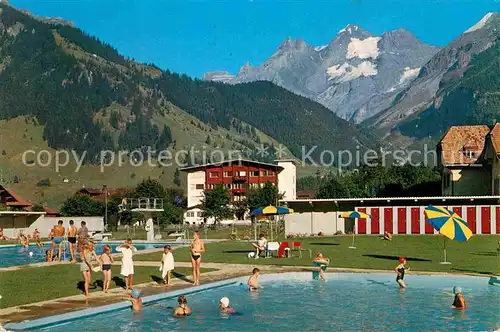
(10, 0, 500, 77)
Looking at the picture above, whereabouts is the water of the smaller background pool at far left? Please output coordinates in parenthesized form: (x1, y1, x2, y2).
(0, 242, 180, 268)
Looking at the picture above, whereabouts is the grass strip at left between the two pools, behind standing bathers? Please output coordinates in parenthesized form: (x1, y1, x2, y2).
(0, 264, 213, 308)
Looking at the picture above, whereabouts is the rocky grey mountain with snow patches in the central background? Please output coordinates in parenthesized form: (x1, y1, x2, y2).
(203, 25, 439, 122)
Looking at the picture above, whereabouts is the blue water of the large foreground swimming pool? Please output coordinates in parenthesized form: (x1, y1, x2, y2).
(40, 272, 500, 332)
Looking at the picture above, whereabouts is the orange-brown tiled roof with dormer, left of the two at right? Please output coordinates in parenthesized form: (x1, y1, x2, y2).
(439, 125, 490, 165)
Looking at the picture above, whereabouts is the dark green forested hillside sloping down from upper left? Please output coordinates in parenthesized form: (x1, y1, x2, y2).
(0, 4, 376, 162)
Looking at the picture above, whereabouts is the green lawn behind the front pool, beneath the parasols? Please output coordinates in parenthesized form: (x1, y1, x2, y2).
(134, 235, 500, 274)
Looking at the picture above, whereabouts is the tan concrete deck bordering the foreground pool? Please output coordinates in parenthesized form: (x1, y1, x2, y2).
(0, 260, 494, 325)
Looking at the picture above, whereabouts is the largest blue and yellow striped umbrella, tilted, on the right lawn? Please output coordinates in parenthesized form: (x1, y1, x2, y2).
(425, 205, 472, 242)
